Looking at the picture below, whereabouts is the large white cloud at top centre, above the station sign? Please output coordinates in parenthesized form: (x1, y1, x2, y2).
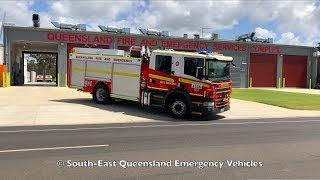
(130, 1, 241, 36)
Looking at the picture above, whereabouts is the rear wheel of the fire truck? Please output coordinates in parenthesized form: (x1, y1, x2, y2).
(92, 84, 111, 104)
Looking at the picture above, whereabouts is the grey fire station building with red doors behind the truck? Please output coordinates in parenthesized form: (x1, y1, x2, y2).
(0, 26, 318, 88)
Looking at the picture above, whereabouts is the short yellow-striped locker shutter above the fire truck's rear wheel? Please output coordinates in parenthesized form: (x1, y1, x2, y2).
(86, 61, 112, 79)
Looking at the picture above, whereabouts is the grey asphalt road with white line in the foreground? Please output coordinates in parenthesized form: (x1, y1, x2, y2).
(0, 119, 320, 180)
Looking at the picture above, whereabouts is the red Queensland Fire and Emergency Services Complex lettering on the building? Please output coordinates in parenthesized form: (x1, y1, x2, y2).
(47, 32, 280, 54)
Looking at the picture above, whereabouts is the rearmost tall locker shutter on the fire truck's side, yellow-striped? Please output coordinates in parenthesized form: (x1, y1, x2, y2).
(70, 59, 86, 87)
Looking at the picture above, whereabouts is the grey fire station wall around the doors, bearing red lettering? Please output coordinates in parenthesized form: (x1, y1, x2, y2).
(4, 27, 317, 88)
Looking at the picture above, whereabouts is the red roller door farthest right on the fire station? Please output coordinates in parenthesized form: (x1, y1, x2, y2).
(282, 55, 308, 88)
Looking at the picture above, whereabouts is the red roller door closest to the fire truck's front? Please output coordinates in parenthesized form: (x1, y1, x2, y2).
(249, 53, 277, 87)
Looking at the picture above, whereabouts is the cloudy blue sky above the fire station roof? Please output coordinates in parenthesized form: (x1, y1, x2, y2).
(0, 0, 320, 46)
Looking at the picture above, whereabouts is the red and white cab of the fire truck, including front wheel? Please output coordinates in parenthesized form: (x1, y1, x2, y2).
(144, 50, 233, 118)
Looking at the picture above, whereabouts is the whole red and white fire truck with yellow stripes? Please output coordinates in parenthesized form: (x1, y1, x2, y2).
(69, 46, 233, 118)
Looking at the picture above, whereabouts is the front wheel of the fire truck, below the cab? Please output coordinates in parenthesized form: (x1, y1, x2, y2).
(168, 96, 190, 119)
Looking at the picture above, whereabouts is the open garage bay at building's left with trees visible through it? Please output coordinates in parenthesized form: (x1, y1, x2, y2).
(9, 41, 58, 86)
